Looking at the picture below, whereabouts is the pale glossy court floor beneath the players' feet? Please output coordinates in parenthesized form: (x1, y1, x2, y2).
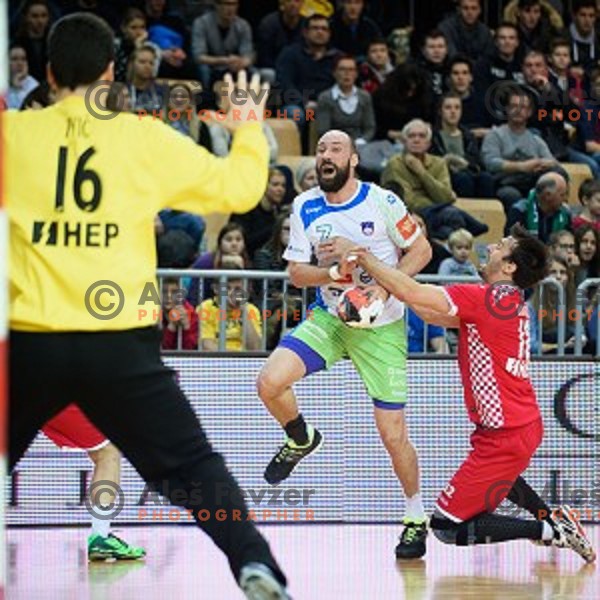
(7, 524, 600, 600)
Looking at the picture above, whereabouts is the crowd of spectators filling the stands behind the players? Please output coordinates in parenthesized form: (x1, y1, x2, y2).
(7, 0, 600, 352)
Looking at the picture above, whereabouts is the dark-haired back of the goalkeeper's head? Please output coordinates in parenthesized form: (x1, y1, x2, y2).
(48, 13, 114, 90)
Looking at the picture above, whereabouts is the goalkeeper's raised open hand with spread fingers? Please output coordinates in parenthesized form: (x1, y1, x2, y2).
(221, 70, 269, 130)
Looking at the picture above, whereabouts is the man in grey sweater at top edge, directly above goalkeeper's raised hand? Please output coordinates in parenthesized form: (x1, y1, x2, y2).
(192, 0, 254, 90)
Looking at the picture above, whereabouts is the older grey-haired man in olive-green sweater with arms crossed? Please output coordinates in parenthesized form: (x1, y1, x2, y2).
(381, 119, 456, 213)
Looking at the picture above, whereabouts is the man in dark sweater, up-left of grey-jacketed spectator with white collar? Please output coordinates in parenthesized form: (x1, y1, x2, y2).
(276, 14, 338, 128)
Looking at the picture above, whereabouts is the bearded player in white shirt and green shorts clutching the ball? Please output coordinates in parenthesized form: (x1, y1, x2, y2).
(258, 130, 431, 558)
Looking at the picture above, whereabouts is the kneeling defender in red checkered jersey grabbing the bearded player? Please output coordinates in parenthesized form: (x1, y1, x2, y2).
(340, 228, 596, 562)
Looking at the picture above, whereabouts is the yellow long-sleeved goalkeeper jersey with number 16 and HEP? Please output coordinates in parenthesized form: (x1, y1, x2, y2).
(2, 96, 269, 332)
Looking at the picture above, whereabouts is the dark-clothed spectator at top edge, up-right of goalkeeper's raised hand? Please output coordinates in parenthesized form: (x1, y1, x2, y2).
(256, 0, 303, 75)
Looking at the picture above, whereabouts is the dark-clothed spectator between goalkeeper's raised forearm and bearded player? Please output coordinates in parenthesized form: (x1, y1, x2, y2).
(231, 169, 286, 256)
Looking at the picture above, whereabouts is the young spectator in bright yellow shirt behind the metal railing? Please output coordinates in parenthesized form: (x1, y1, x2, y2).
(196, 262, 262, 352)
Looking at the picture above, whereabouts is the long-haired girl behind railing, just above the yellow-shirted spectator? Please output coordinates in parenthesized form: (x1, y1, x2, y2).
(184, 222, 251, 306)
